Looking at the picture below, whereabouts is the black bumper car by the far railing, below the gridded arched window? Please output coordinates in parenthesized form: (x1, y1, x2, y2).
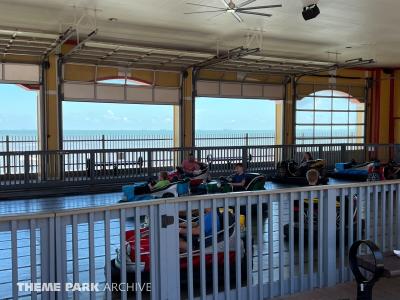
(269, 159, 329, 185)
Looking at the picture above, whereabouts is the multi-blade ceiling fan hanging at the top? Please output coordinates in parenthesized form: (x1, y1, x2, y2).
(185, 0, 282, 22)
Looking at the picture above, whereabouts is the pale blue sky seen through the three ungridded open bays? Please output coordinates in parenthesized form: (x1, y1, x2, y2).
(0, 84, 275, 130)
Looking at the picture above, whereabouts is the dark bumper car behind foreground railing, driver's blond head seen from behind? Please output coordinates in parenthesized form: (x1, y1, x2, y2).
(283, 194, 365, 242)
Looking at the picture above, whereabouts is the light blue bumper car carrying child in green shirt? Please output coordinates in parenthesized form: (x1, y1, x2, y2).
(122, 180, 189, 202)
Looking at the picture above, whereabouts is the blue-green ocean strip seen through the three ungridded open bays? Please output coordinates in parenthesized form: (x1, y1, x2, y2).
(0, 130, 275, 152)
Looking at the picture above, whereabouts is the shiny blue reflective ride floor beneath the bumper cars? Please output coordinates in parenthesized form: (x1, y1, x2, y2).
(0, 179, 368, 299)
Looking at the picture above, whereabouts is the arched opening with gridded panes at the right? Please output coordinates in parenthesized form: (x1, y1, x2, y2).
(296, 90, 365, 144)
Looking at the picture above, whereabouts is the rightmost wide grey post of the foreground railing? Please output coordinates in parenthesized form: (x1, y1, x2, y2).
(320, 189, 336, 287)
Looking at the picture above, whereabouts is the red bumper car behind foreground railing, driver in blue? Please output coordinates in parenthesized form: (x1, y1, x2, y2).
(111, 212, 247, 283)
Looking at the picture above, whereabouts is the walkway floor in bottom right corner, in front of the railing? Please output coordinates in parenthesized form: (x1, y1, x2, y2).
(276, 277, 400, 300)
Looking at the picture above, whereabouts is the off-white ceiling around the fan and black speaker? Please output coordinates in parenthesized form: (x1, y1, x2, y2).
(0, 0, 400, 67)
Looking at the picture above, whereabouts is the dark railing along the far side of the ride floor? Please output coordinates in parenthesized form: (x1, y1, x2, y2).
(0, 144, 400, 190)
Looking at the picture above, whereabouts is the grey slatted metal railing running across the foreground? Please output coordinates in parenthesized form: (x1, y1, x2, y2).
(0, 181, 400, 299)
